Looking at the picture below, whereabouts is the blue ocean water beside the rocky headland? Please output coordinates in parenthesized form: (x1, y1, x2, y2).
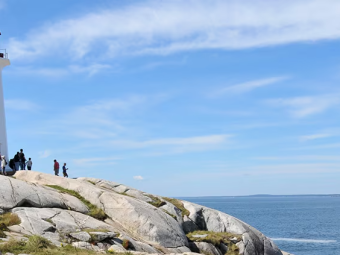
(181, 196, 340, 255)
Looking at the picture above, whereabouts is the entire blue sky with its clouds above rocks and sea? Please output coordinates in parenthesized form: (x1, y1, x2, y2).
(0, 0, 340, 196)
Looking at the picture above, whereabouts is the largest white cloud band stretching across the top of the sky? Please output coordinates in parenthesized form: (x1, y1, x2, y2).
(7, 0, 340, 60)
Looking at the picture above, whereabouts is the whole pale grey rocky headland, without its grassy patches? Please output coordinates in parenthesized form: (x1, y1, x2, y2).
(6, 171, 288, 255)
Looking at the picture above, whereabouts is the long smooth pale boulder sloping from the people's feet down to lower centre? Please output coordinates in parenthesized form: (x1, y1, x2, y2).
(15, 171, 188, 248)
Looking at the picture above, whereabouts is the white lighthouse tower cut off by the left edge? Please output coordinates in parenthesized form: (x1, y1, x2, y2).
(0, 49, 11, 171)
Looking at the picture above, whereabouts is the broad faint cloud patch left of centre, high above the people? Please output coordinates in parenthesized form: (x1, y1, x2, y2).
(34, 94, 167, 141)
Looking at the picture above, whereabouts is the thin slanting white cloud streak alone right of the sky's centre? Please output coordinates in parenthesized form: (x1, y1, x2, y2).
(212, 77, 288, 96)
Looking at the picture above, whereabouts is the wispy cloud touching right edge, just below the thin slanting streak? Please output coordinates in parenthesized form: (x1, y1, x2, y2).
(268, 93, 340, 118)
